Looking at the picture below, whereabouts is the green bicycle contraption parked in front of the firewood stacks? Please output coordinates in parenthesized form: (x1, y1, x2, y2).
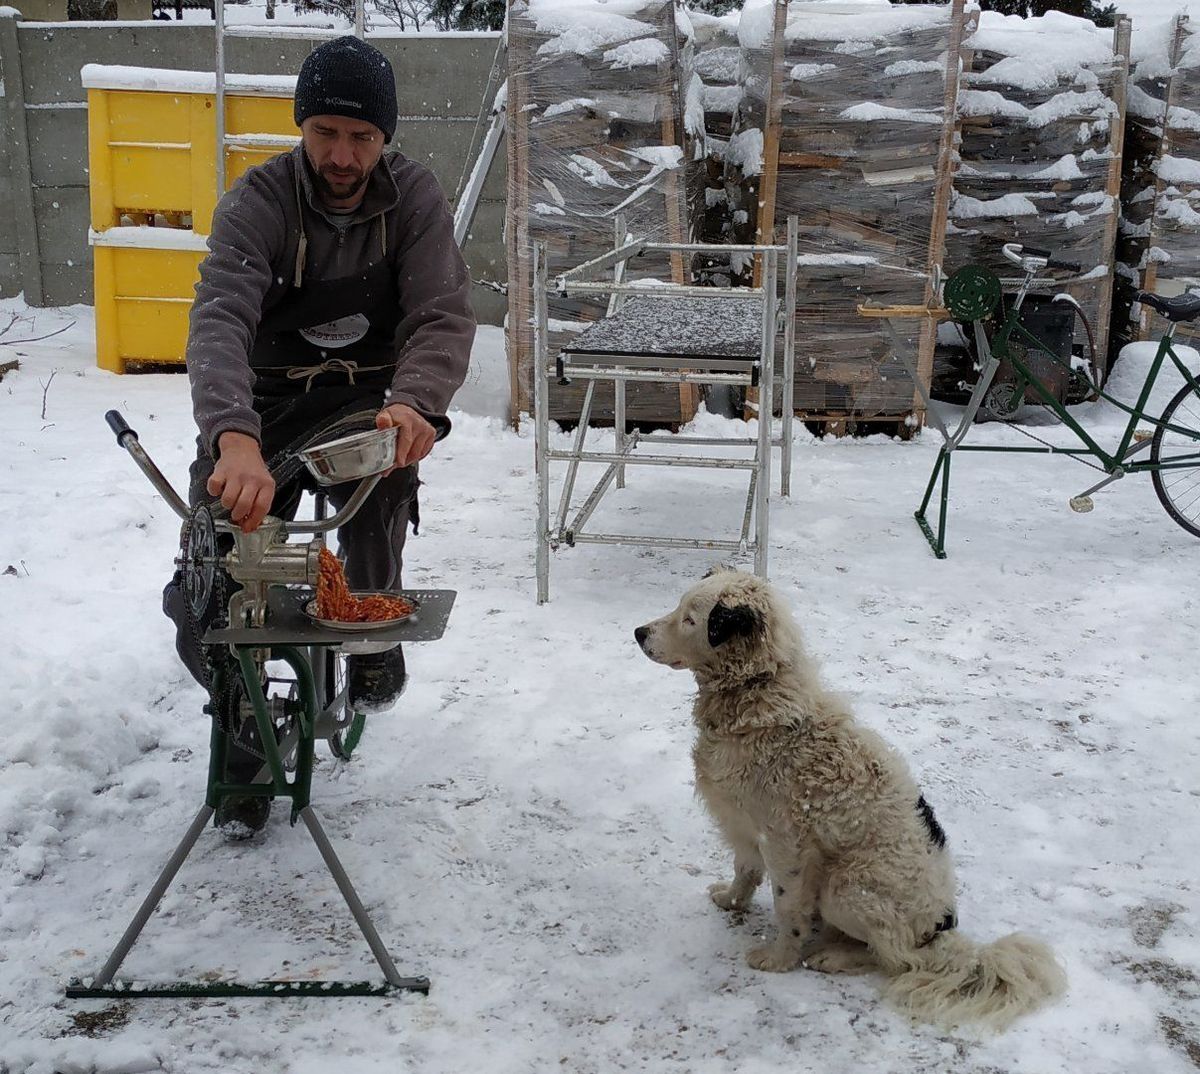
(914, 242, 1200, 559)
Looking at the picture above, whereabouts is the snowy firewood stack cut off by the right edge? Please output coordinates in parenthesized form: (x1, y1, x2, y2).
(1110, 16, 1200, 356)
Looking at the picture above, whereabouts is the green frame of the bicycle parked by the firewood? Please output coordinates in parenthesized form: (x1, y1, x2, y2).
(914, 269, 1200, 559)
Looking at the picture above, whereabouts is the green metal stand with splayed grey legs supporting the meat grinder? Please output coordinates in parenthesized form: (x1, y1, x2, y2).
(66, 644, 430, 1000)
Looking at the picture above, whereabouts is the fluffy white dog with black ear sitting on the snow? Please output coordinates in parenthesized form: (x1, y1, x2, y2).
(635, 569, 1066, 1030)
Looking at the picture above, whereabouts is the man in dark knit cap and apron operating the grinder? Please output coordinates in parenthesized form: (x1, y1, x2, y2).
(166, 37, 475, 827)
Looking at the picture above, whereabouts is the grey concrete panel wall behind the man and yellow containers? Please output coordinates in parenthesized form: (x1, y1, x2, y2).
(0, 16, 506, 324)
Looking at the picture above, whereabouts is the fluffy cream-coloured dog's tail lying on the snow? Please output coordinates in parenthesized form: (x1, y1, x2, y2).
(886, 929, 1067, 1032)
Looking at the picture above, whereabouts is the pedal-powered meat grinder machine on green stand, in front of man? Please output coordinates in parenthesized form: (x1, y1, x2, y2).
(66, 410, 455, 998)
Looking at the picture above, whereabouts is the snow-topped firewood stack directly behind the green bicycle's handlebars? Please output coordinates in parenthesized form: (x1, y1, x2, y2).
(946, 12, 1130, 380)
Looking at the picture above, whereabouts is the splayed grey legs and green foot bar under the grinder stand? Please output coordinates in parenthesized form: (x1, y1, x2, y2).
(66, 805, 430, 1000)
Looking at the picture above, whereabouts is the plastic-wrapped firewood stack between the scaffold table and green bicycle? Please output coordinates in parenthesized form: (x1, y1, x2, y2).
(728, 0, 964, 434)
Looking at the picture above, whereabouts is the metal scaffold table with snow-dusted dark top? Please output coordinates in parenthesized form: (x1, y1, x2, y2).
(534, 217, 798, 604)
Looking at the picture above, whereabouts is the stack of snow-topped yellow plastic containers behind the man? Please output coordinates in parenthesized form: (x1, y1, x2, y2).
(82, 65, 299, 373)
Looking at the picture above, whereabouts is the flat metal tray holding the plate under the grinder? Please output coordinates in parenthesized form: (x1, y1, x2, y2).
(204, 586, 457, 650)
